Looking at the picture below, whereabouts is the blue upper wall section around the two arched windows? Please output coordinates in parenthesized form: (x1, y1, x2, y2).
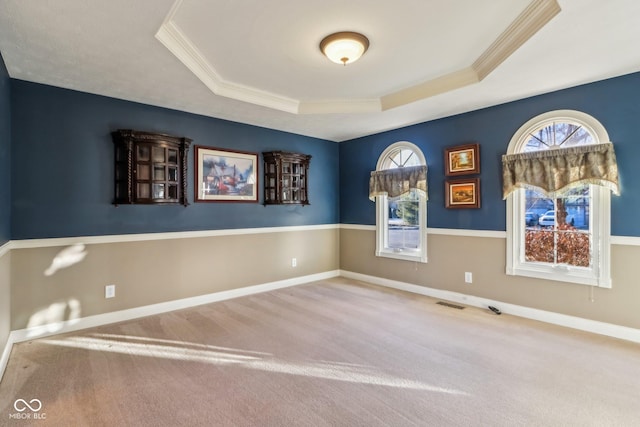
(340, 73, 640, 236)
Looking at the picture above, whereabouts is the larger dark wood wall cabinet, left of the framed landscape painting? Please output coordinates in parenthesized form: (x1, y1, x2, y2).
(112, 129, 191, 206)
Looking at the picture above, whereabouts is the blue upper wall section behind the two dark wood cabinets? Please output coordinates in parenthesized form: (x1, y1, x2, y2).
(11, 80, 339, 239)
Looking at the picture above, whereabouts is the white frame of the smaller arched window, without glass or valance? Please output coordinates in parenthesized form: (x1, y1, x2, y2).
(376, 141, 427, 263)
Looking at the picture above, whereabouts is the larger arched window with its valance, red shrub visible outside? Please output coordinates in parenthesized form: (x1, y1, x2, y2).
(502, 110, 619, 287)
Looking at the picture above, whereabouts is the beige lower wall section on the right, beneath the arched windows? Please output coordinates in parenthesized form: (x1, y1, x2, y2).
(340, 229, 640, 329)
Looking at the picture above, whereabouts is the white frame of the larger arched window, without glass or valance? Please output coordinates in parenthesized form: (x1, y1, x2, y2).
(506, 110, 611, 288)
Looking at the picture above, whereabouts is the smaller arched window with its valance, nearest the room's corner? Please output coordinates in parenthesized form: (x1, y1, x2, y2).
(369, 141, 427, 262)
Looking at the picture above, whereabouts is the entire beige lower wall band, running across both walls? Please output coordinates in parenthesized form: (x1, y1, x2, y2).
(6, 227, 640, 338)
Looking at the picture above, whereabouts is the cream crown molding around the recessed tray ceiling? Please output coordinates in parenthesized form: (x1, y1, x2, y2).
(155, 0, 561, 114)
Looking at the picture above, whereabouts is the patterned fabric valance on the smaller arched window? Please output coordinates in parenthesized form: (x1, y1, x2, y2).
(369, 166, 427, 201)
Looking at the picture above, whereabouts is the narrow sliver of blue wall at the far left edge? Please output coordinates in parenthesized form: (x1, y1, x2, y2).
(0, 54, 11, 246)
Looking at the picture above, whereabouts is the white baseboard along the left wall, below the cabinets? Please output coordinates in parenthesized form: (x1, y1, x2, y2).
(0, 270, 340, 380)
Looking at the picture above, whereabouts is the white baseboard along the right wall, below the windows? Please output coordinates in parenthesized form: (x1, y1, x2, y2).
(340, 270, 640, 343)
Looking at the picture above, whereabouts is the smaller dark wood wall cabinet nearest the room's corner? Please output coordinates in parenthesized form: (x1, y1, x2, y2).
(262, 151, 311, 205)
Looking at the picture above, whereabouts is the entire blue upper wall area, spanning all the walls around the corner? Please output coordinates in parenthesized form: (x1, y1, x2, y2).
(8, 72, 640, 244)
